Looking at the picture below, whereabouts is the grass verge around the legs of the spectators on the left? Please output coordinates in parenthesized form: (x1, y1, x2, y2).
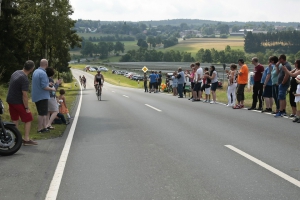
(0, 79, 78, 140)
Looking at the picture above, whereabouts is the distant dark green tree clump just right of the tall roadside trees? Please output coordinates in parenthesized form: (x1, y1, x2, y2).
(80, 41, 125, 59)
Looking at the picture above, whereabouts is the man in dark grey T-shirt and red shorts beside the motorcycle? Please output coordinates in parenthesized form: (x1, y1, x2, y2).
(6, 60, 37, 145)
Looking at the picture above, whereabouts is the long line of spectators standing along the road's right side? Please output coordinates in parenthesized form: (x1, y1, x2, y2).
(144, 54, 300, 123)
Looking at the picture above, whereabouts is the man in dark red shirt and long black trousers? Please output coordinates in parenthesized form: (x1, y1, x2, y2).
(248, 57, 264, 110)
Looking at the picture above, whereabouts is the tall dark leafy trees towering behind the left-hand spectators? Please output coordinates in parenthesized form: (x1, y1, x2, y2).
(0, 0, 80, 81)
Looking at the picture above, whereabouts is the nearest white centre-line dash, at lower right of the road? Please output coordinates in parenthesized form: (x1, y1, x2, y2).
(225, 145, 300, 187)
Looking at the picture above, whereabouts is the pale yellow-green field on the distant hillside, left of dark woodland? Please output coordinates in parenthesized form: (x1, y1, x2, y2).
(162, 37, 244, 56)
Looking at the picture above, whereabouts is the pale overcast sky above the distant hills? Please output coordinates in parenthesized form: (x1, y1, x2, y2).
(70, 0, 300, 22)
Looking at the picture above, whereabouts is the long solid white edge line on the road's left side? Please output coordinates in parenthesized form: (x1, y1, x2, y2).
(45, 77, 82, 200)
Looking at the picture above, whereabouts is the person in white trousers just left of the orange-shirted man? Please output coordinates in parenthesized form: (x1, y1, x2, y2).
(227, 64, 238, 107)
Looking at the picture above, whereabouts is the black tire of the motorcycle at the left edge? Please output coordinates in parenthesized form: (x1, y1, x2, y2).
(0, 125, 22, 156)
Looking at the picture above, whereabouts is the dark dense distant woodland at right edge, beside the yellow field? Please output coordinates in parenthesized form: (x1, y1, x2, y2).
(244, 31, 300, 54)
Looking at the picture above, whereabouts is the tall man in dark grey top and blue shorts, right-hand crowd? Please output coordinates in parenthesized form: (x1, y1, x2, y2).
(274, 55, 292, 117)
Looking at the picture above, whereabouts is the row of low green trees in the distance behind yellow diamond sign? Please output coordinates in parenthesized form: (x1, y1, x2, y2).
(120, 48, 195, 62)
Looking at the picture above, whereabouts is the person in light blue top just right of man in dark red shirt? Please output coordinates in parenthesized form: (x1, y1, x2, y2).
(261, 59, 273, 113)
